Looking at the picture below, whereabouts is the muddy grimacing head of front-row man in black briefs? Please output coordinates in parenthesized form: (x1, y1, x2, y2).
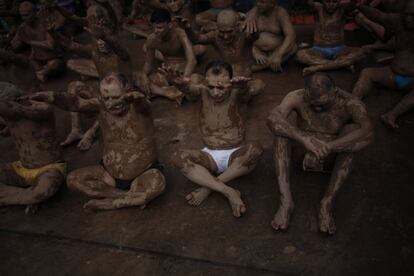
(99, 73, 129, 116)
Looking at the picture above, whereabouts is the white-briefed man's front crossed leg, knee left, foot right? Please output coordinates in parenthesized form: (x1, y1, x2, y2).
(172, 151, 246, 217)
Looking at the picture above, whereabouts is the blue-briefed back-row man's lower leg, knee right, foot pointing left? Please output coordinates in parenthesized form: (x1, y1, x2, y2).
(303, 47, 367, 76)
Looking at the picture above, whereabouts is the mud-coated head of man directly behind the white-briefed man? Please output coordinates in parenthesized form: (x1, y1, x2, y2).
(217, 10, 239, 44)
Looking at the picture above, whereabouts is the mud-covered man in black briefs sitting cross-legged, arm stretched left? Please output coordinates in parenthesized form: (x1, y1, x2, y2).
(24, 73, 166, 210)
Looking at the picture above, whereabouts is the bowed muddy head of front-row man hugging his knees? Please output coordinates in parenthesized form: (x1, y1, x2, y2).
(305, 73, 338, 112)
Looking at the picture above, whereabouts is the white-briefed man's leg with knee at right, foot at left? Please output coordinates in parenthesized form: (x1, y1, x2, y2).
(186, 143, 263, 206)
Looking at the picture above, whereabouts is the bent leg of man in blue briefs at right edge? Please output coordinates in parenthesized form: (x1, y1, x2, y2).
(352, 67, 396, 99)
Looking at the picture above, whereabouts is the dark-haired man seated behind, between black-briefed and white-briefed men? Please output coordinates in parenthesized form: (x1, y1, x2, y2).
(136, 10, 197, 103)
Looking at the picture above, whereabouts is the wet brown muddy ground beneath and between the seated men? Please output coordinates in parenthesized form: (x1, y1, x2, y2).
(0, 25, 414, 275)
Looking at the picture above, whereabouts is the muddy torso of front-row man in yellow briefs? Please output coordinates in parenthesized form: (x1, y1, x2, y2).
(7, 114, 63, 169)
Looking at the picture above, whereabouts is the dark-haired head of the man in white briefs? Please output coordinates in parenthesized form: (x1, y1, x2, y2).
(205, 61, 233, 103)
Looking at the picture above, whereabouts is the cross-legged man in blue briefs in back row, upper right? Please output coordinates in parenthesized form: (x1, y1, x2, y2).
(297, 0, 368, 76)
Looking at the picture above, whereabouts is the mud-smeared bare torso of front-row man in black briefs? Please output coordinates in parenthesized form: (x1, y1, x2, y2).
(98, 103, 157, 180)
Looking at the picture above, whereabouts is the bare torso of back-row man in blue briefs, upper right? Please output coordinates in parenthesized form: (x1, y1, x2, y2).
(314, 8, 345, 47)
